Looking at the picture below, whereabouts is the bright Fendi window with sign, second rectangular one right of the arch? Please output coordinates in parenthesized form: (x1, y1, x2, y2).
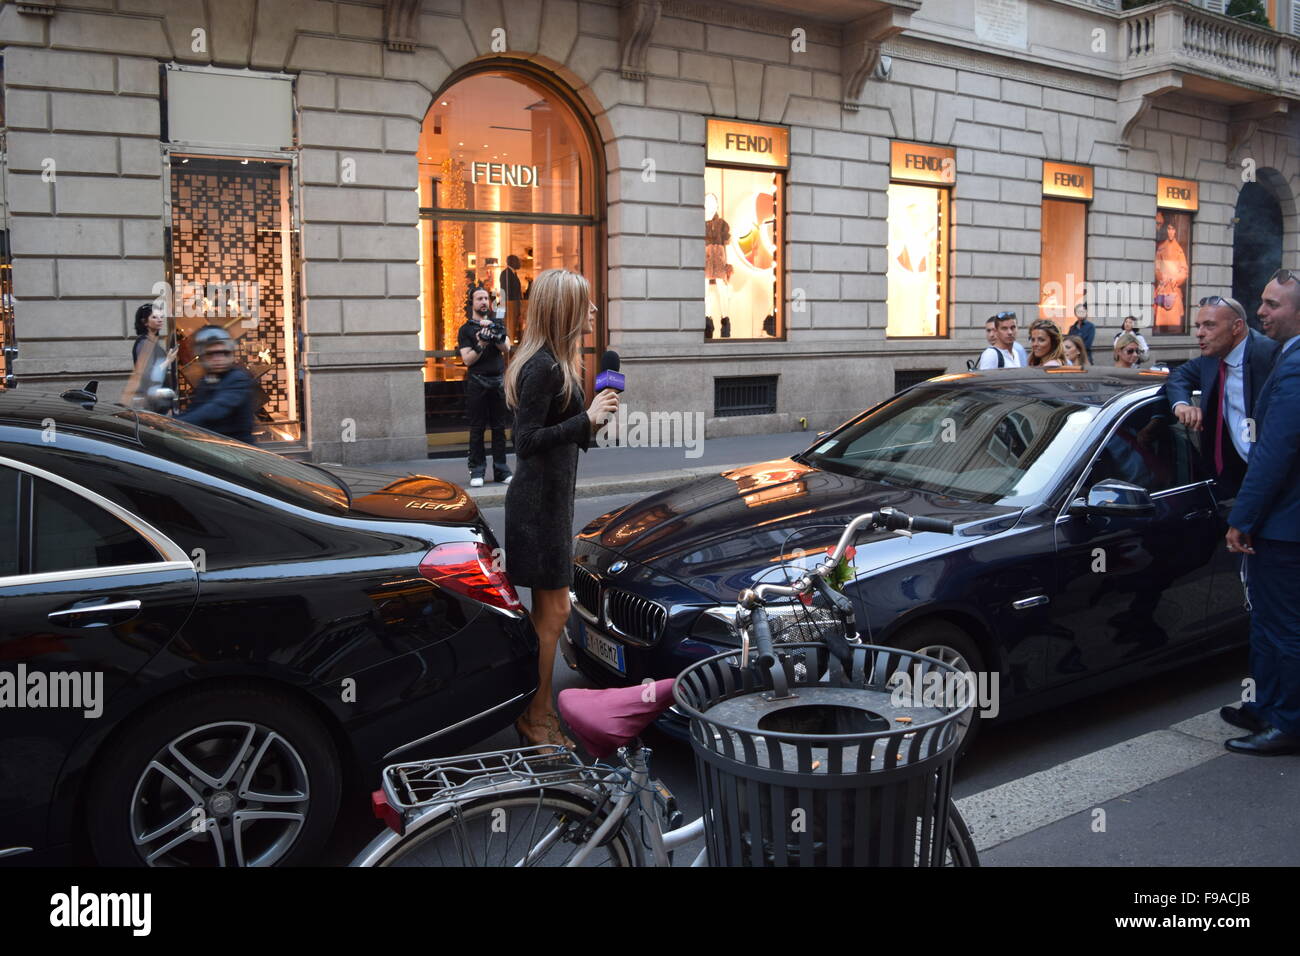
(885, 143, 957, 338)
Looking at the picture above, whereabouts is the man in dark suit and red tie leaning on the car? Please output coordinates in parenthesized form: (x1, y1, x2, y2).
(1165, 295, 1278, 501)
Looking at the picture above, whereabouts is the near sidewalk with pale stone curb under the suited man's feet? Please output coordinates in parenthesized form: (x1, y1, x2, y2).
(957, 708, 1300, 866)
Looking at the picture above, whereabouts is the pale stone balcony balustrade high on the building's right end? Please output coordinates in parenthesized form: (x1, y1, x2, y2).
(1121, 0, 1300, 96)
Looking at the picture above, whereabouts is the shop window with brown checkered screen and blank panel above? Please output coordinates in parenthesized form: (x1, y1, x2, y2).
(155, 64, 306, 442)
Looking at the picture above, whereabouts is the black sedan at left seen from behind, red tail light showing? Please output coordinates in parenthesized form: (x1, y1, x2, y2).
(0, 392, 537, 866)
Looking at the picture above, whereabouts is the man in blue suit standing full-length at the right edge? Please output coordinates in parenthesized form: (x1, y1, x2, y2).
(1219, 269, 1300, 756)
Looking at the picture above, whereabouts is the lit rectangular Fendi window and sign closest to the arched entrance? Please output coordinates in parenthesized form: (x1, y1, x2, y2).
(705, 120, 790, 341)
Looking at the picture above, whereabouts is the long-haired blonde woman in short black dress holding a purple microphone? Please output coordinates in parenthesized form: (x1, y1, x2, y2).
(506, 269, 619, 747)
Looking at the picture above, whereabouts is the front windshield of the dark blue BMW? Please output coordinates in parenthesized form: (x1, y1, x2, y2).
(806, 386, 1099, 505)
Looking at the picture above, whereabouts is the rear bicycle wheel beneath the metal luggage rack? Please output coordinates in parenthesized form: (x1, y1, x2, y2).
(376, 790, 640, 866)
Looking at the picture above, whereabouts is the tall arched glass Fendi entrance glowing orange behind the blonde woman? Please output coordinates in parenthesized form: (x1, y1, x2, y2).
(419, 62, 607, 455)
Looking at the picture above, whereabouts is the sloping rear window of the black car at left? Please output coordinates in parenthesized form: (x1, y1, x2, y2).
(137, 411, 351, 515)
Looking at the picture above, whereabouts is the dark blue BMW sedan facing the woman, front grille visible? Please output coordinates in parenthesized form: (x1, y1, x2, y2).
(566, 368, 1245, 743)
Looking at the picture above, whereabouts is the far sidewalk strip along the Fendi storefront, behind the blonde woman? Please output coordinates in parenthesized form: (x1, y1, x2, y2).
(321, 432, 816, 507)
